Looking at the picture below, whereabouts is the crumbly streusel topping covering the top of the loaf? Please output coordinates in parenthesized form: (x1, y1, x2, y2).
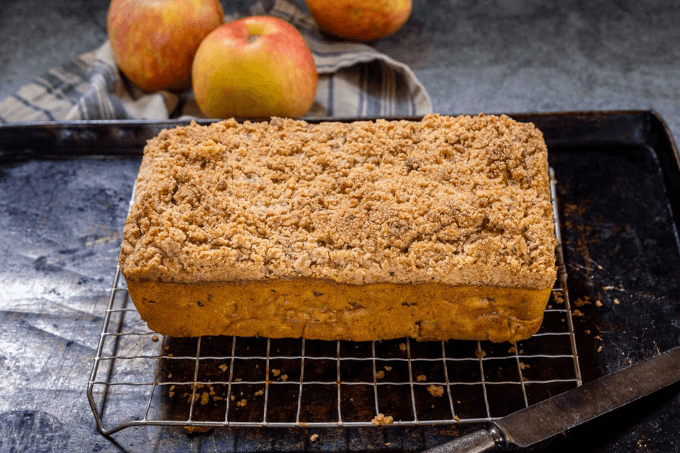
(120, 115, 556, 289)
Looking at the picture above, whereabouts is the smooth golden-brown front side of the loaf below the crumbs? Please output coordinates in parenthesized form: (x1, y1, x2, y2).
(128, 278, 552, 342)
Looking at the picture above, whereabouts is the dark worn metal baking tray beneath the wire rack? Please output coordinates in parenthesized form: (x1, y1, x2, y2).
(0, 112, 680, 452)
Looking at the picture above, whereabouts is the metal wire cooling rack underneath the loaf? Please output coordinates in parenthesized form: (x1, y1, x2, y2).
(87, 169, 581, 435)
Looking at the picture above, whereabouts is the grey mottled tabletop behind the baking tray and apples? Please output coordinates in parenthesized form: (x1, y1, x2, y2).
(0, 0, 680, 143)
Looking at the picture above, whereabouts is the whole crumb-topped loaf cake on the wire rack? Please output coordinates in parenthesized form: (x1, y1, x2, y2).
(120, 114, 556, 342)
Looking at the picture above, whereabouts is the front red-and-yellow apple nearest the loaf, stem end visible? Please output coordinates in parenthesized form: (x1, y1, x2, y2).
(192, 16, 318, 118)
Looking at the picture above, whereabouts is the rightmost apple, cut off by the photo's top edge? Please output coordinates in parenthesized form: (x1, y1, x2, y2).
(306, 0, 411, 41)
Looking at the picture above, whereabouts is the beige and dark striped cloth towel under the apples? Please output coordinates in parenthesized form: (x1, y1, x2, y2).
(0, 0, 432, 123)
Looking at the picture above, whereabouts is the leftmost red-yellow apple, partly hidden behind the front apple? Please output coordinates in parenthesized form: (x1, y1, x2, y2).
(107, 0, 224, 91)
